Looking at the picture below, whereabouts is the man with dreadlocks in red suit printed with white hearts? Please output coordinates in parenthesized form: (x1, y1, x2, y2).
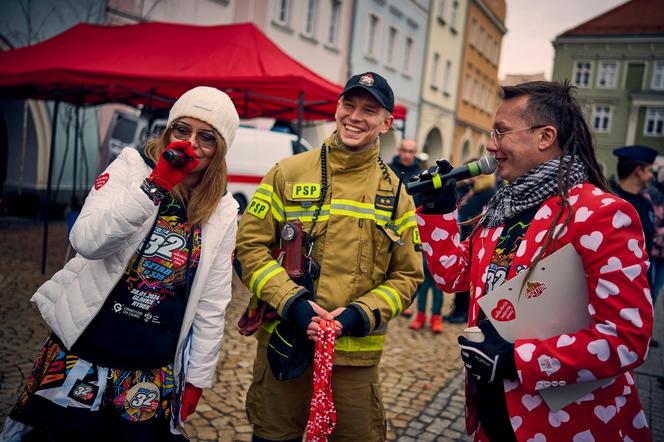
(417, 82, 653, 442)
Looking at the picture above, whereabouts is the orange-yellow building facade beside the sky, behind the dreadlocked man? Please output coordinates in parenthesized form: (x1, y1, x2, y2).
(452, 0, 507, 165)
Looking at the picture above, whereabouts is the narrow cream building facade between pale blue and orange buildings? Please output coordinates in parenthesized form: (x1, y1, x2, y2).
(416, 0, 468, 163)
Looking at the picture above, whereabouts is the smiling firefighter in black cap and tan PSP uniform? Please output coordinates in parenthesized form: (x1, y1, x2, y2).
(236, 72, 422, 441)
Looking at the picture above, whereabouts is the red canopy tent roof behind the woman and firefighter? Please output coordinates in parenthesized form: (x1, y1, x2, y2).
(0, 22, 406, 120)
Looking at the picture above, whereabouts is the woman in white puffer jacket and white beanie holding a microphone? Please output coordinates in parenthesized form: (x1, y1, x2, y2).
(0, 86, 239, 441)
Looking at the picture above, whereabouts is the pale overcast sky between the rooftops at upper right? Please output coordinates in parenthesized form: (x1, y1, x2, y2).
(498, 0, 625, 80)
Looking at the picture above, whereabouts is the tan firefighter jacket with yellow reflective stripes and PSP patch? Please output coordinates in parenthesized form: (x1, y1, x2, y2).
(236, 134, 422, 366)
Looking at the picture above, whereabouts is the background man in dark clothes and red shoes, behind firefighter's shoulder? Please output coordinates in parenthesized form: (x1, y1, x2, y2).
(390, 139, 443, 333)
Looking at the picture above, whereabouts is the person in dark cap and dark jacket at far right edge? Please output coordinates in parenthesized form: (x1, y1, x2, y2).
(611, 146, 657, 290)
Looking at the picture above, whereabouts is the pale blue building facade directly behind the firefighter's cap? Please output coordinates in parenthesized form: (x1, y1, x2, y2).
(348, 0, 429, 158)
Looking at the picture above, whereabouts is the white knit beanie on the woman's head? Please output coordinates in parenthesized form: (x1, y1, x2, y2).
(167, 86, 240, 149)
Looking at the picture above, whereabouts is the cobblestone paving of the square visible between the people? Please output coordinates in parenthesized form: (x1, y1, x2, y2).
(0, 218, 664, 441)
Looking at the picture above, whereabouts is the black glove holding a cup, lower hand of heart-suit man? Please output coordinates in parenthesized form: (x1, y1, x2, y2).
(458, 319, 517, 383)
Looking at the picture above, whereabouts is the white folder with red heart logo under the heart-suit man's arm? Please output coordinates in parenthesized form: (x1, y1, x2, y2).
(478, 244, 612, 411)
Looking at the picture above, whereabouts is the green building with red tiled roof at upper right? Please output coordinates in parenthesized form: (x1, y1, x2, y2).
(552, 0, 664, 176)
